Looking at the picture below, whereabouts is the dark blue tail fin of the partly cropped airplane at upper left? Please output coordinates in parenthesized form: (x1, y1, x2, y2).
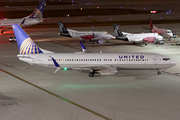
(29, 0, 46, 19)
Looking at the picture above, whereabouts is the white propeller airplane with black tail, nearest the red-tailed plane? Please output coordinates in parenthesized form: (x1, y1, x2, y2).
(113, 24, 164, 45)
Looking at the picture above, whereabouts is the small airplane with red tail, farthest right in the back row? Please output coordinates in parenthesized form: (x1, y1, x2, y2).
(149, 18, 177, 40)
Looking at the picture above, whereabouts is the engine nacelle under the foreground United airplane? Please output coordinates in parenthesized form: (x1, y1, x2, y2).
(98, 68, 118, 75)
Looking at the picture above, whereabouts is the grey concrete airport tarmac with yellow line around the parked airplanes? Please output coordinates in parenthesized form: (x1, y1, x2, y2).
(0, 24, 180, 120)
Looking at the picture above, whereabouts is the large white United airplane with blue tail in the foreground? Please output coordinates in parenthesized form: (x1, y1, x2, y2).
(12, 24, 176, 77)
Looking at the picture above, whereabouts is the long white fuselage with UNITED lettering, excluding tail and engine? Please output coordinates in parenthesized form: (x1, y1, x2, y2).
(18, 53, 176, 70)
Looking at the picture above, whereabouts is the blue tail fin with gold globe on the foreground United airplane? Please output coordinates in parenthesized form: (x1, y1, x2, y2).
(12, 24, 43, 54)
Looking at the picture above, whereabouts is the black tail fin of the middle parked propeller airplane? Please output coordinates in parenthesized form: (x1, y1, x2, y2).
(113, 24, 128, 41)
